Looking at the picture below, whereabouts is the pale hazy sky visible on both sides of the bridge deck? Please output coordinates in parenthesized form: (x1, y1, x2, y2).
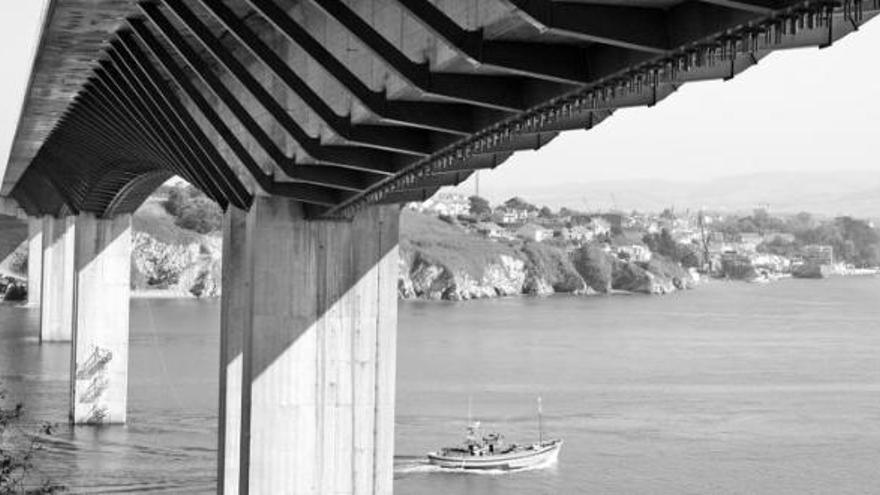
(0, 0, 880, 200)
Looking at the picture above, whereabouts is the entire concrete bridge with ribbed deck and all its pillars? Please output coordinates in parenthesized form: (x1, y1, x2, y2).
(0, 0, 880, 494)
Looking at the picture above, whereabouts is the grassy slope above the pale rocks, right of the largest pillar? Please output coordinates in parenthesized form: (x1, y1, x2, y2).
(400, 209, 521, 278)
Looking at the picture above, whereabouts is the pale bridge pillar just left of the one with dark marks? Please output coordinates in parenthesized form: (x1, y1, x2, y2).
(40, 216, 75, 342)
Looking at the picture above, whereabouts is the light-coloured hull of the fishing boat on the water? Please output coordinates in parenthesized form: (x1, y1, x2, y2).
(428, 440, 562, 470)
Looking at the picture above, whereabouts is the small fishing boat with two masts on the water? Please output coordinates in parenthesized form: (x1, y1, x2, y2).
(428, 398, 562, 470)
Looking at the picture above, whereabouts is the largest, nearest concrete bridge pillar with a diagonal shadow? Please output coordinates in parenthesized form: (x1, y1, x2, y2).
(220, 197, 399, 495)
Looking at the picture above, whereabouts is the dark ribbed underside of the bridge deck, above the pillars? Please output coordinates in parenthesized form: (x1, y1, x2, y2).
(8, 0, 878, 221)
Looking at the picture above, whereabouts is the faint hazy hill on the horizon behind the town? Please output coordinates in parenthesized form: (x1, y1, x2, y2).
(474, 170, 880, 219)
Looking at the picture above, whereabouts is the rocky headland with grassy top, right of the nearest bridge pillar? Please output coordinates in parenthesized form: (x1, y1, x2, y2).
(398, 212, 696, 301)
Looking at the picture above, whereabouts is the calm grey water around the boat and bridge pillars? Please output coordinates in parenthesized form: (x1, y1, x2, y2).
(0, 278, 880, 495)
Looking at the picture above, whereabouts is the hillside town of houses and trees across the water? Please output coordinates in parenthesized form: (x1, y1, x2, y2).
(407, 193, 880, 282)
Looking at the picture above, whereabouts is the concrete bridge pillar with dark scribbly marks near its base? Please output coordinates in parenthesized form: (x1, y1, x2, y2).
(70, 213, 131, 424)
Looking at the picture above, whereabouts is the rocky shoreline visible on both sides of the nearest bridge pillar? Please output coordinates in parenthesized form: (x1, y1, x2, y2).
(132, 207, 695, 301)
